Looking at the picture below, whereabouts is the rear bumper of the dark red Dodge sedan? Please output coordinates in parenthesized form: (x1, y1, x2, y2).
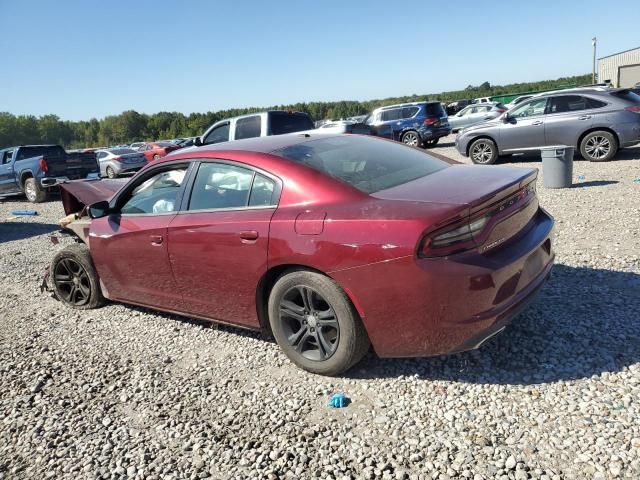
(332, 209, 555, 357)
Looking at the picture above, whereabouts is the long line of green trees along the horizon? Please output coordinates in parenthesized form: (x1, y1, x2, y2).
(0, 74, 591, 148)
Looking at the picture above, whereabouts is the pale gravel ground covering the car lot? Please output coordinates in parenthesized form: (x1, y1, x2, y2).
(0, 137, 640, 480)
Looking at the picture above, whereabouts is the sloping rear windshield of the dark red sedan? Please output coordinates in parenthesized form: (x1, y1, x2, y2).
(272, 137, 449, 193)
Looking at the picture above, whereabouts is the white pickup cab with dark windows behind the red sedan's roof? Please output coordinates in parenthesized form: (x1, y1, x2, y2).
(196, 110, 315, 145)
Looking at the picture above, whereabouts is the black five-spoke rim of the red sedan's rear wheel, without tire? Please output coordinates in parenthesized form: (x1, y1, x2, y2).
(279, 286, 340, 361)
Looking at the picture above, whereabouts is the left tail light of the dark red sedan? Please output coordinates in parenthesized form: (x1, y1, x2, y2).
(420, 216, 489, 257)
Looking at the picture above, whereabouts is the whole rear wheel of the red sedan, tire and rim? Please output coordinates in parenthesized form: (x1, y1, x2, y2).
(269, 271, 370, 375)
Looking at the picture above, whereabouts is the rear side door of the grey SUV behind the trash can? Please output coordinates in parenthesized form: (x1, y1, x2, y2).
(544, 95, 606, 147)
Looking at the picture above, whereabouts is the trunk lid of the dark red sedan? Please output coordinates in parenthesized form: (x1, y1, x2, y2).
(372, 165, 539, 253)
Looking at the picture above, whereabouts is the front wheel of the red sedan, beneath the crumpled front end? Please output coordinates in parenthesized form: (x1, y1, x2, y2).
(49, 243, 105, 310)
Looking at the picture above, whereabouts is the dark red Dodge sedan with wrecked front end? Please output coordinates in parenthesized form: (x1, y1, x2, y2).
(50, 134, 554, 375)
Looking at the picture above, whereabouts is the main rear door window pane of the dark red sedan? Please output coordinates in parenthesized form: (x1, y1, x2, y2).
(189, 163, 253, 210)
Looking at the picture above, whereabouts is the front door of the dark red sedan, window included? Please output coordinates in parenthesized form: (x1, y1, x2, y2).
(89, 165, 187, 311)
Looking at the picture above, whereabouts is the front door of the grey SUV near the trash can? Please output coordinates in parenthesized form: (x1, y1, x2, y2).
(499, 98, 547, 151)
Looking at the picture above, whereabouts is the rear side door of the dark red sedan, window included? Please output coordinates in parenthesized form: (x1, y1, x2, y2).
(168, 162, 279, 327)
